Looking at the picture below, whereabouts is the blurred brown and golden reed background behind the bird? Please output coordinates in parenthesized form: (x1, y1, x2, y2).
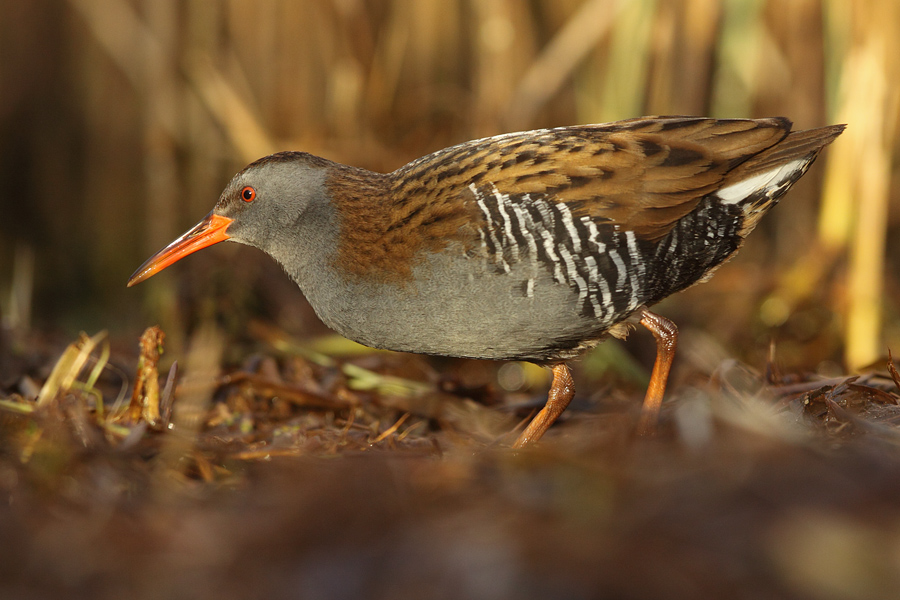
(0, 0, 900, 374)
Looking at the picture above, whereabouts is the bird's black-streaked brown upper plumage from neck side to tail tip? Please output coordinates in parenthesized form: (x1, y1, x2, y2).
(338, 117, 841, 280)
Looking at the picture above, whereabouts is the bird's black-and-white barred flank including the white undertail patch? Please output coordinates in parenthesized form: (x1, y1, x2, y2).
(469, 152, 814, 325)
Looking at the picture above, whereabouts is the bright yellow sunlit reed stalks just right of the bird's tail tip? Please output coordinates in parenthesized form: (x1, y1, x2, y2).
(819, 0, 900, 369)
